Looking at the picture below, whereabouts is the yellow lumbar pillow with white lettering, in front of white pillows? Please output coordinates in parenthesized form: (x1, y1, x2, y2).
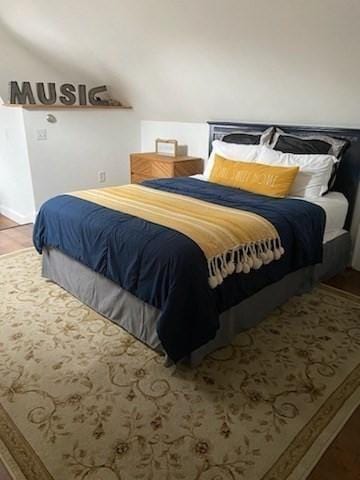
(209, 155, 299, 198)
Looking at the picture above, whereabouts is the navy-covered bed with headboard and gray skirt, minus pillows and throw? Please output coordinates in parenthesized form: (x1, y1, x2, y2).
(34, 123, 360, 365)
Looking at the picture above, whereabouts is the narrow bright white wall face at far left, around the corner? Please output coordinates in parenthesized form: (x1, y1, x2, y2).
(0, 106, 34, 223)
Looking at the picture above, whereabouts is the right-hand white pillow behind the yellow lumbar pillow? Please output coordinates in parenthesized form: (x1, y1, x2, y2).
(256, 146, 337, 198)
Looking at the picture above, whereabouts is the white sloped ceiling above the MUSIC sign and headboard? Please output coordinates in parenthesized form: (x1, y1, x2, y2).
(0, 0, 360, 126)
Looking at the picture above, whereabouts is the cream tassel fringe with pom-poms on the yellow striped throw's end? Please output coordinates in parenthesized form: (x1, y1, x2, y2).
(208, 237, 285, 288)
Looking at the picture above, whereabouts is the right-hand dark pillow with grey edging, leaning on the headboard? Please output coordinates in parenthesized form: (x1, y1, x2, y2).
(270, 128, 349, 159)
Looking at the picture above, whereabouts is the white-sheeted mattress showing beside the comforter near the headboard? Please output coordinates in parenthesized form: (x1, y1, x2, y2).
(193, 175, 349, 243)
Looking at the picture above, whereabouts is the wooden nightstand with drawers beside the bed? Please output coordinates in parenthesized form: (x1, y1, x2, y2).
(130, 153, 203, 183)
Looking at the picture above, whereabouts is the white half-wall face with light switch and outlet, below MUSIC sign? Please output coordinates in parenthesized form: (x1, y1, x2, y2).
(24, 110, 140, 209)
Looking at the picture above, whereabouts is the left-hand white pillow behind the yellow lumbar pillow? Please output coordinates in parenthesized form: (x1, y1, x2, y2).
(204, 140, 261, 180)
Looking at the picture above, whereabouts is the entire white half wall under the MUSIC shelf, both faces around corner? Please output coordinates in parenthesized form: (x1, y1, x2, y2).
(0, 107, 140, 219)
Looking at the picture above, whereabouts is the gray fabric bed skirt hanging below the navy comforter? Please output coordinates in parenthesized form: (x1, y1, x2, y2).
(42, 232, 351, 365)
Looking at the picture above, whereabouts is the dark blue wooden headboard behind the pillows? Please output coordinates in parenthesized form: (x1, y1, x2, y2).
(208, 122, 360, 230)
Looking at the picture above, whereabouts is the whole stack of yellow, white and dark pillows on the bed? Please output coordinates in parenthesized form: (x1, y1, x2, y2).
(204, 128, 348, 198)
